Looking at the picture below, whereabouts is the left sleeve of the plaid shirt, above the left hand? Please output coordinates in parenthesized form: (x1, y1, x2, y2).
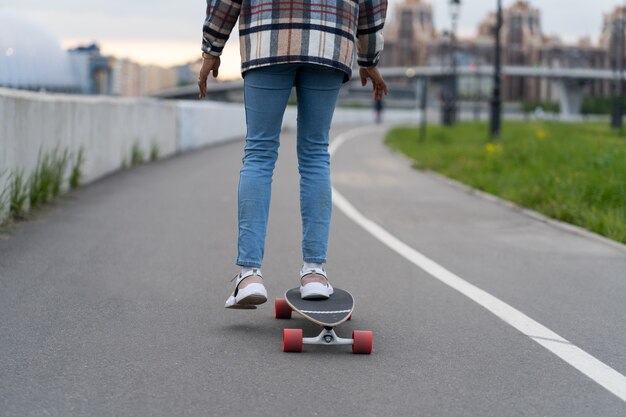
(202, 0, 242, 56)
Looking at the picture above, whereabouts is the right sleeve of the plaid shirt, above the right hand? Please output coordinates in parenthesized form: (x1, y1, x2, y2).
(356, 0, 387, 67)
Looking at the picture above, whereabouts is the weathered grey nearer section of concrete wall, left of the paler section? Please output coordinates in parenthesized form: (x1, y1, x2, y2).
(0, 90, 177, 182)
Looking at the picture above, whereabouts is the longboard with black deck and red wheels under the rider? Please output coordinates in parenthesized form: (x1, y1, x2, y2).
(274, 288, 372, 354)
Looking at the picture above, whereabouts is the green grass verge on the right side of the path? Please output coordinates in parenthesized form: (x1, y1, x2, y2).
(386, 121, 626, 243)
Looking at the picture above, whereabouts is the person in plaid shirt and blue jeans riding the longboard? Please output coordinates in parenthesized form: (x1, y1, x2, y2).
(198, 0, 387, 309)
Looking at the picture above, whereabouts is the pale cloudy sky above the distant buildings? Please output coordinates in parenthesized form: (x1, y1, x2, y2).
(0, 0, 621, 76)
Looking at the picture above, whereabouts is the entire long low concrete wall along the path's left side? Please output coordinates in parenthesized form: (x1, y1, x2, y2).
(0, 88, 418, 220)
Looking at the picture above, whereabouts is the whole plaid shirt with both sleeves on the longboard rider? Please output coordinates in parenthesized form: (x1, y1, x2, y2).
(202, 0, 387, 82)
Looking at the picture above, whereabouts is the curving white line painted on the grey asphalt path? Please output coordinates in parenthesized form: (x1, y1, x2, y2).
(329, 128, 626, 402)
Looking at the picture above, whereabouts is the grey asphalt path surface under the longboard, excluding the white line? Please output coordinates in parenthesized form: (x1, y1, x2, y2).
(0, 122, 626, 417)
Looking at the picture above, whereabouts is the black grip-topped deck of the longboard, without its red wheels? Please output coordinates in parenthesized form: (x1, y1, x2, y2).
(285, 288, 354, 327)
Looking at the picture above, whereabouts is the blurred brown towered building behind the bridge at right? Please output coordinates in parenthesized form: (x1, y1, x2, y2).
(381, 0, 626, 101)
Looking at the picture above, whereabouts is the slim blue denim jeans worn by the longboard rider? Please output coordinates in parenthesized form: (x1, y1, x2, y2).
(237, 64, 343, 267)
